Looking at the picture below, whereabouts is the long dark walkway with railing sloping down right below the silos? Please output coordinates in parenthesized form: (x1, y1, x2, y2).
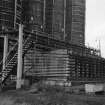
(24, 30, 100, 57)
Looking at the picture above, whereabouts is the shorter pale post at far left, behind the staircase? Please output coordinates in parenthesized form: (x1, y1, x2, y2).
(3, 35, 8, 69)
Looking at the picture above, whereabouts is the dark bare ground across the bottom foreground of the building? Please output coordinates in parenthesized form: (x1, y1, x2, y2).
(0, 90, 105, 105)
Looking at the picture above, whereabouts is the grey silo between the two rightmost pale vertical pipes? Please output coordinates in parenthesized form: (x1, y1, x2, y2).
(45, 0, 64, 40)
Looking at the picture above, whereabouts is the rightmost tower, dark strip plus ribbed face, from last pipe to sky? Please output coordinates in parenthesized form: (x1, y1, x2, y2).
(65, 0, 85, 45)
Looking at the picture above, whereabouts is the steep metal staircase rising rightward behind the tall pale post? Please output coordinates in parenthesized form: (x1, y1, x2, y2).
(0, 35, 33, 87)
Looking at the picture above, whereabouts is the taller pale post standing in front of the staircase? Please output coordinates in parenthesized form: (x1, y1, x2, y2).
(16, 24, 23, 89)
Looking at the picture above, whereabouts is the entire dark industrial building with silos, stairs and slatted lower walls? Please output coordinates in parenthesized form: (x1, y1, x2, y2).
(0, 0, 105, 88)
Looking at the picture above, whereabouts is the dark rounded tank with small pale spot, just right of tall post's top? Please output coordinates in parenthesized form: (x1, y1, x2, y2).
(23, 0, 44, 31)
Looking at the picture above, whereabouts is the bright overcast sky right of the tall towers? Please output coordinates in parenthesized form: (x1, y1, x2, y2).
(86, 0, 105, 57)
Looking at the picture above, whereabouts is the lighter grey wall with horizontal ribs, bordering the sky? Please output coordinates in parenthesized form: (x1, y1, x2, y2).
(71, 0, 85, 45)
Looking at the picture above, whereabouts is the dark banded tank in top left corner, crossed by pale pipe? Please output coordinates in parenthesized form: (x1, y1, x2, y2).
(0, 0, 21, 31)
